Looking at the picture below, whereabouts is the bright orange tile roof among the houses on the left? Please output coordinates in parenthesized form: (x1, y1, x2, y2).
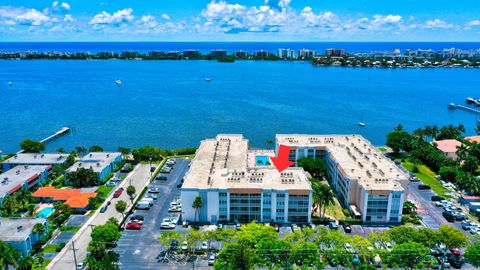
(32, 187, 97, 213)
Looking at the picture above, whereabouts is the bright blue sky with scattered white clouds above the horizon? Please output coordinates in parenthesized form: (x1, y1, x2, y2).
(0, 0, 480, 41)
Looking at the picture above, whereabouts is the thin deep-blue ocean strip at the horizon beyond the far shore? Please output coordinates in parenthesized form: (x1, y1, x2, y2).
(0, 42, 480, 53)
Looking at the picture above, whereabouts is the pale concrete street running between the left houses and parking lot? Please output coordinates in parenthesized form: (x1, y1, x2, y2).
(47, 164, 151, 270)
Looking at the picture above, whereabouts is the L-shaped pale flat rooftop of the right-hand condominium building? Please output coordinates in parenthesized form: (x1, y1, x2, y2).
(276, 134, 408, 190)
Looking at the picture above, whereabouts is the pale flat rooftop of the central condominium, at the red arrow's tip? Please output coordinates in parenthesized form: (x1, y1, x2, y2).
(182, 134, 311, 191)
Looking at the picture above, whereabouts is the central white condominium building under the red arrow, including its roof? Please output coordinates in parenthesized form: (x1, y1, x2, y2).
(181, 134, 312, 223)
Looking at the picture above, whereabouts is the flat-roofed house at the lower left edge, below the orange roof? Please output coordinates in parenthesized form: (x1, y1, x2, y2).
(0, 218, 49, 256)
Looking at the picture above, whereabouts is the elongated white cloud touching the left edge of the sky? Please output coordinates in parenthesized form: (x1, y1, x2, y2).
(0, 6, 51, 26)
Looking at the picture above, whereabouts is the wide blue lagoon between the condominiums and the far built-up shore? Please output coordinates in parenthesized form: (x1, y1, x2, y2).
(0, 43, 480, 153)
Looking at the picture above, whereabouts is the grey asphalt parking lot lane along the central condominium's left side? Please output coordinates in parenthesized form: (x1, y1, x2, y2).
(115, 159, 190, 269)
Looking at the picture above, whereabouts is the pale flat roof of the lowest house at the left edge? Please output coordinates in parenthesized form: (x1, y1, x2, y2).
(0, 218, 47, 242)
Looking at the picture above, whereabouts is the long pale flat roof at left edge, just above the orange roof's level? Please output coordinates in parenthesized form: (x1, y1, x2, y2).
(0, 165, 49, 197)
